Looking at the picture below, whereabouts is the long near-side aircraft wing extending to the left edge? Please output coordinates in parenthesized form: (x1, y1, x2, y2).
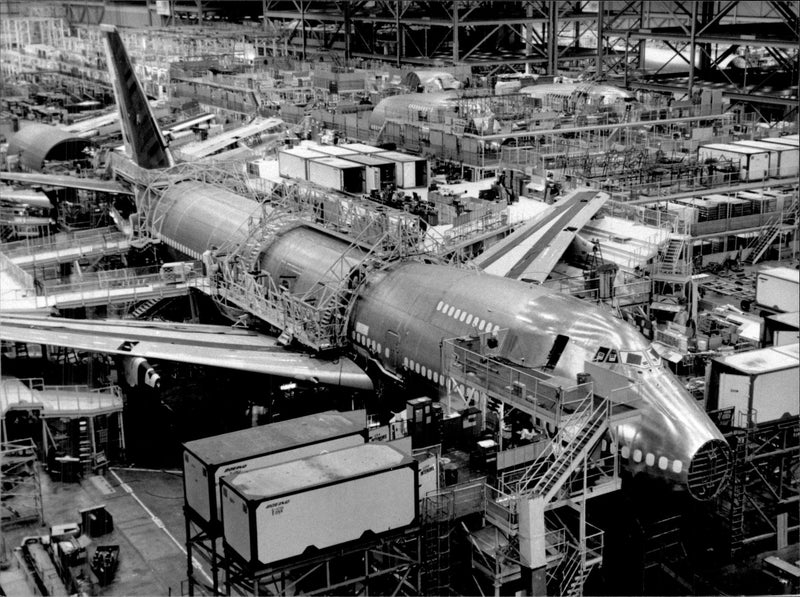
(0, 315, 372, 390)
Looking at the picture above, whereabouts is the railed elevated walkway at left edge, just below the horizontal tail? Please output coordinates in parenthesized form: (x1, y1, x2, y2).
(0, 227, 131, 270)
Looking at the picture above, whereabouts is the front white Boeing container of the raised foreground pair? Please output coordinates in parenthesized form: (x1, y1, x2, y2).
(221, 443, 418, 569)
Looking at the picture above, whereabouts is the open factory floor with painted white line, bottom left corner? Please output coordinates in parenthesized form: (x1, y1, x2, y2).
(0, 469, 196, 596)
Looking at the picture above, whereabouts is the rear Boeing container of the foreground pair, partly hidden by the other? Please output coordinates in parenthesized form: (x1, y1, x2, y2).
(183, 410, 367, 530)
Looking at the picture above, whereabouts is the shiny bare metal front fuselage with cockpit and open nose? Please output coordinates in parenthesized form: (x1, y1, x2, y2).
(350, 263, 728, 499)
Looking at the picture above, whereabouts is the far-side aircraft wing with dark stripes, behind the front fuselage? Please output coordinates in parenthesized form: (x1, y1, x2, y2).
(473, 189, 608, 283)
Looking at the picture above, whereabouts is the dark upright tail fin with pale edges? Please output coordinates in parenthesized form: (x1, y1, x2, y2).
(101, 25, 175, 170)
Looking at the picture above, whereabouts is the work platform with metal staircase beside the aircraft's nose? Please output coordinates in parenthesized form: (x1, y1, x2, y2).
(428, 330, 640, 595)
